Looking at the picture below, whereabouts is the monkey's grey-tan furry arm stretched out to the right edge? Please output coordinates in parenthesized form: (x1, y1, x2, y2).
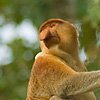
(64, 71, 100, 95)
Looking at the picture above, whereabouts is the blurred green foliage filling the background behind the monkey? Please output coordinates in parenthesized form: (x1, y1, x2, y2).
(0, 0, 100, 100)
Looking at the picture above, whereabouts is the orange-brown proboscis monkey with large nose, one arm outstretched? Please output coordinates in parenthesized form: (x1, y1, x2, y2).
(26, 19, 100, 100)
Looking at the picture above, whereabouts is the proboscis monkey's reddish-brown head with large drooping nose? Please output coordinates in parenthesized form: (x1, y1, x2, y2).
(39, 19, 78, 53)
